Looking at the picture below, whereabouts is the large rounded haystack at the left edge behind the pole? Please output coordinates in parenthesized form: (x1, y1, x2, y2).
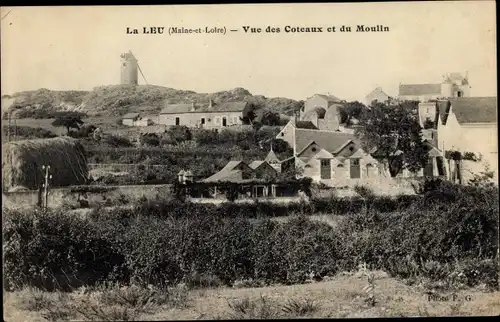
(2, 137, 89, 191)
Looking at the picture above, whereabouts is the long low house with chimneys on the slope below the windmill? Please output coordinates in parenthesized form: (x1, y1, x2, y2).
(158, 100, 248, 129)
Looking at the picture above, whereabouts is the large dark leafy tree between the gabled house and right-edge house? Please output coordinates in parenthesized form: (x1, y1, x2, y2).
(356, 102, 428, 177)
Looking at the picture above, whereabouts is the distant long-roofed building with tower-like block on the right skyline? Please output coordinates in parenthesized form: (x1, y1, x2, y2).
(398, 72, 470, 102)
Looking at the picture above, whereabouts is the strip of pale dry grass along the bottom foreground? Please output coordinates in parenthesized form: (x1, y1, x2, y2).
(4, 272, 500, 321)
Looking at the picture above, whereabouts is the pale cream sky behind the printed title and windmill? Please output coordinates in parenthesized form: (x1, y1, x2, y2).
(0, 1, 497, 100)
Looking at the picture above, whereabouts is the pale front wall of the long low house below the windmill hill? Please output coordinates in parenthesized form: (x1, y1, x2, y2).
(159, 112, 242, 128)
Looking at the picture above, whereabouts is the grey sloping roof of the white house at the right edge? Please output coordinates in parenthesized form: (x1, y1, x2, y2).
(449, 97, 497, 124)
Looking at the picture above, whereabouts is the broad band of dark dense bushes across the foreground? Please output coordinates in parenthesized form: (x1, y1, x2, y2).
(3, 183, 499, 289)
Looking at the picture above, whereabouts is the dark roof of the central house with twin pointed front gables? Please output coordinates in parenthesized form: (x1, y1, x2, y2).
(295, 129, 357, 153)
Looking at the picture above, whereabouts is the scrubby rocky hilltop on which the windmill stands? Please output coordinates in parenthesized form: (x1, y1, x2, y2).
(2, 85, 302, 116)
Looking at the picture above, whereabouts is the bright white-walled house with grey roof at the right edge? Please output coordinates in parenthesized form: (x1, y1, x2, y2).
(436, 97, 498, 181)
